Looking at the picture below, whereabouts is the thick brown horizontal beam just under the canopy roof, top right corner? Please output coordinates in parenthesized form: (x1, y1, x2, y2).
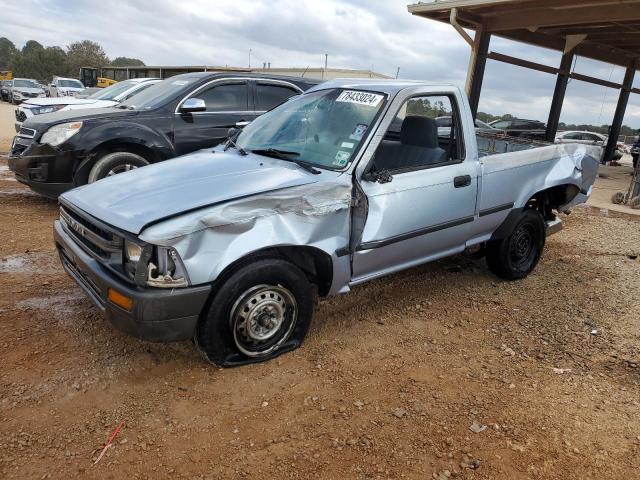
(487, 2, 640, 32)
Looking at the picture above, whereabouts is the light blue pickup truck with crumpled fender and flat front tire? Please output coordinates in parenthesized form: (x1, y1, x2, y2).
(54, 80, 601, 366)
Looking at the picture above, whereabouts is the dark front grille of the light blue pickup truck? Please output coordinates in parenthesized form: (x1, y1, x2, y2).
(60, 206, 123, 262)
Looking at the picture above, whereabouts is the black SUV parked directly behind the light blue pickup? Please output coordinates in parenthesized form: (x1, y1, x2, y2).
(9, 72, 317, 198)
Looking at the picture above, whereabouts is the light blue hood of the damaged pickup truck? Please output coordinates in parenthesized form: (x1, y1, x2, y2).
(60, 149, 339, 234)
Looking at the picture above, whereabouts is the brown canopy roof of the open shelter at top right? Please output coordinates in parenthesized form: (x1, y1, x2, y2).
(408, 0, 640, 67)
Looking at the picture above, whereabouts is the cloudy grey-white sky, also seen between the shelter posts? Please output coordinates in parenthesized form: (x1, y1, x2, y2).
(0, 0, 640, 128)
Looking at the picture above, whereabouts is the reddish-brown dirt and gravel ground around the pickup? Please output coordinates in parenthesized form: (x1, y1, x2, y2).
(0, 109, 640, 480)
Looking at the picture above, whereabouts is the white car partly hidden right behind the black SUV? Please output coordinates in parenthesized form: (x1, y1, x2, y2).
(15, 78, 161, 132)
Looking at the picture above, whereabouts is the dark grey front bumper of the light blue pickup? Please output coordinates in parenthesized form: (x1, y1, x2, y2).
(53, 220, 211, 342)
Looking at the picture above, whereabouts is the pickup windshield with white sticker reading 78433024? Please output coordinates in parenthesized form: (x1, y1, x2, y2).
(236, 89, 385, 169)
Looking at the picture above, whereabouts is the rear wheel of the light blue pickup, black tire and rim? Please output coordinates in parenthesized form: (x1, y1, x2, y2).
(487, 210, 546, 280)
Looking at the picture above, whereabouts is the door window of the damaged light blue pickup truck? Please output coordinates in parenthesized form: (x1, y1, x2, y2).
(373, 95, 464, 172)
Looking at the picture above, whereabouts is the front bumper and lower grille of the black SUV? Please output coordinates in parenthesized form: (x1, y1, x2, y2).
(9, 137, 77, 199)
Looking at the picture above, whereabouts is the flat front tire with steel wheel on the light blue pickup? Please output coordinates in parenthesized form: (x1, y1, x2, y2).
(194, 258, 314, 367)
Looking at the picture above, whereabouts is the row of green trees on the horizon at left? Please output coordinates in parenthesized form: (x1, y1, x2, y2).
(0, 37, 144, 83)
